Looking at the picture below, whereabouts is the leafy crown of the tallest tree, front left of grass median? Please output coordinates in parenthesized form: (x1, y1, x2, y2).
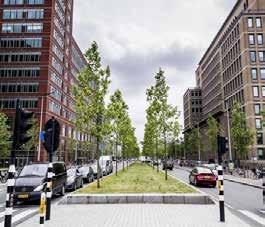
(73, 42, 110, 141)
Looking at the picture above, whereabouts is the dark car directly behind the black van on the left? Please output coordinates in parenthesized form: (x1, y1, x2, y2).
(66, 168, 83, 191)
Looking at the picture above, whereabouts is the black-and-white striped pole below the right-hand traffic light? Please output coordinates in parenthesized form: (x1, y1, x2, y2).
(217, 165, 225, 222)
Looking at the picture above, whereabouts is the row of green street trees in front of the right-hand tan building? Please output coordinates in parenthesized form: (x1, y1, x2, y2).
(182, 103, 254, 163)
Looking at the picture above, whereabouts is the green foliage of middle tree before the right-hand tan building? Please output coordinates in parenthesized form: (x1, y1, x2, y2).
(206, 115, 219, 157)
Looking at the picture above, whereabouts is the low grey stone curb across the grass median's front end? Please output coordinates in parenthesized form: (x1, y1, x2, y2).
(60, 194, 215, 205)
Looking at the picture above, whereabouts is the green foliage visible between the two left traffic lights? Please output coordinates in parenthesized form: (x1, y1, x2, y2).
(22, 118, 40, 152)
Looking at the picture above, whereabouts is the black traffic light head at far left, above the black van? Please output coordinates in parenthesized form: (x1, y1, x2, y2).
(13, 104, 34, 150)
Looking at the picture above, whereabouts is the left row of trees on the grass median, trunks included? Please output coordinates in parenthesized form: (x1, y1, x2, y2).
(73, 42, 139, 187)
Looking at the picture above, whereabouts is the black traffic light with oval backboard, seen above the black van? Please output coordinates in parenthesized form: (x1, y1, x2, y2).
(43, 117, 60, 153)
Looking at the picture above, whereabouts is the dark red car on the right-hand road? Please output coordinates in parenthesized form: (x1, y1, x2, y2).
(189, 167, 217, 187)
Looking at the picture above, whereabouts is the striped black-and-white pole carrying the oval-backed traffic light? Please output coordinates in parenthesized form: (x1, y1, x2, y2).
(46, 117, 55, 220)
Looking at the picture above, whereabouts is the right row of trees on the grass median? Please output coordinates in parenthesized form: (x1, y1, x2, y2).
(142, 69, 180, 180)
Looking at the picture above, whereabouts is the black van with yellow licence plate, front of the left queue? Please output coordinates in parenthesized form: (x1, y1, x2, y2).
(14, 162, 67, 202)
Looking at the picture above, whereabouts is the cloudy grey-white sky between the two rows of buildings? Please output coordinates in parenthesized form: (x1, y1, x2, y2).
(71, 0, 236, 142)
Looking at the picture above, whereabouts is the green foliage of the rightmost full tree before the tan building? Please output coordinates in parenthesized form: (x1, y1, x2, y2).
(231, 103, 254, 159)
